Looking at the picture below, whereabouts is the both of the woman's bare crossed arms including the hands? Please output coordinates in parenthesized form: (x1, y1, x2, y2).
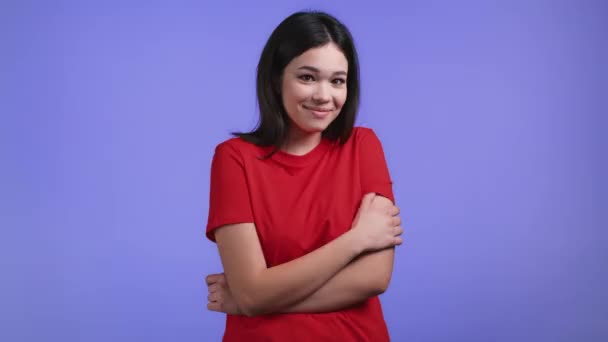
(207, 195, 403, 316)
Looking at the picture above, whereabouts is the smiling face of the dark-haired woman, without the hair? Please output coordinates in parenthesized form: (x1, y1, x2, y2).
(281, 43, 348, 134)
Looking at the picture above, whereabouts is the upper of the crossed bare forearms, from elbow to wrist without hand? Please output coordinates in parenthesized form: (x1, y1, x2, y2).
(250, 232, 361, 315)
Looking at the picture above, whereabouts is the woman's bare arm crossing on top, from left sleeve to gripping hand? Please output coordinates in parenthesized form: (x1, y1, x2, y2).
(215, 194, 401, 316)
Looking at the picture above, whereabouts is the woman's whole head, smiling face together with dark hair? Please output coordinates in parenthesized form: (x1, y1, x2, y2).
(237, 12, 359, 148)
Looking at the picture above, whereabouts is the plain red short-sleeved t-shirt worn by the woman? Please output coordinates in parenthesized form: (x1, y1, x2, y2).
(207, 127, 394, 342)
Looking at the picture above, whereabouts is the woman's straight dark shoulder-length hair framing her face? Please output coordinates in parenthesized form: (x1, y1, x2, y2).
(232, 11, 360, 156)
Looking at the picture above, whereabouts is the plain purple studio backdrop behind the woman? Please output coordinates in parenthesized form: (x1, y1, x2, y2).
(0, 0, 608, 342)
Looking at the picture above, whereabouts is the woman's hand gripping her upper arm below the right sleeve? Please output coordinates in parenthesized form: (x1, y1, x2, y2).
(351, 193, 403, 252)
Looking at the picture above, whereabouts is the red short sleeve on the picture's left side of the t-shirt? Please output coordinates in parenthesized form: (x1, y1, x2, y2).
(206, 143, 253, 242)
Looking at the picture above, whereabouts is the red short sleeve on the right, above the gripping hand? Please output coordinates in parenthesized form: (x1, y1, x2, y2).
(359, 128, 395, 203)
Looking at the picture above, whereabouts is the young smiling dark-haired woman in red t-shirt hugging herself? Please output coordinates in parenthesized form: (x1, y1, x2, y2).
(207, 12, 403, 342)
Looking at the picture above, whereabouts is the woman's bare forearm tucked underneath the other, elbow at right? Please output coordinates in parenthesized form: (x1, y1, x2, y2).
(281, 248, 395, 313)
